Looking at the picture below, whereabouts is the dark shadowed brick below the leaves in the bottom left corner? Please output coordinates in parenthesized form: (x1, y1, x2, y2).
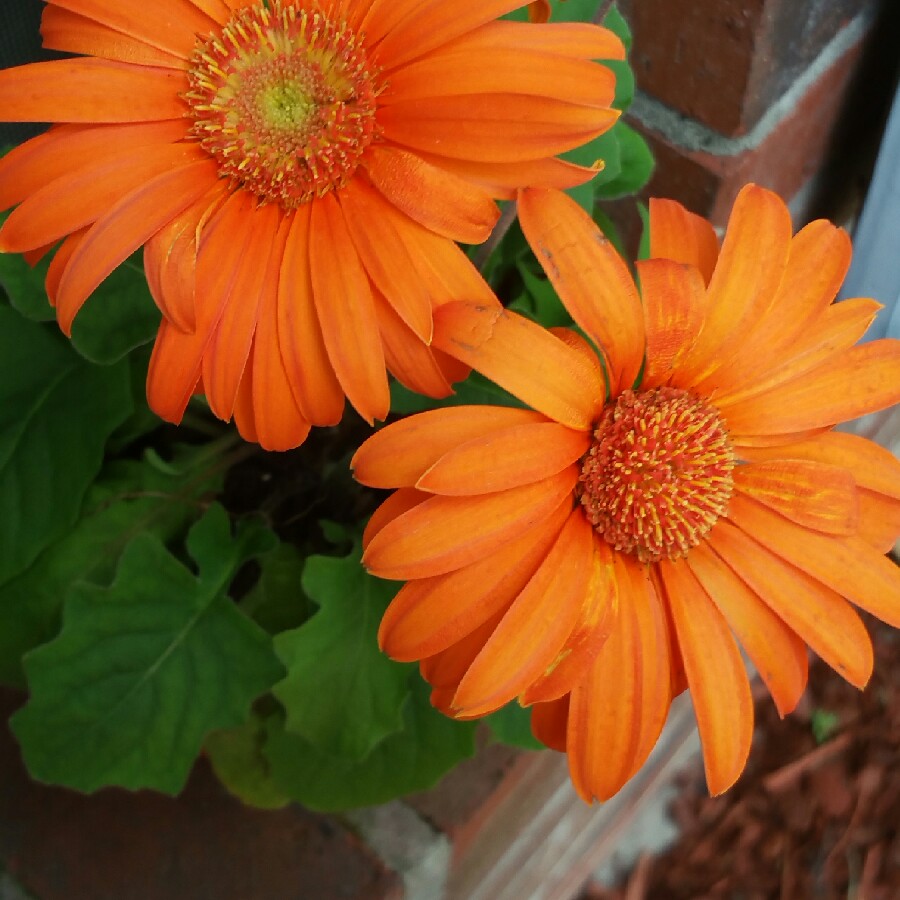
(0, 692, 403, 900)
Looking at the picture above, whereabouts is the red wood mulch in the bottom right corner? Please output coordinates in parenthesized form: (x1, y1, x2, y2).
(583, 622, 900, 900)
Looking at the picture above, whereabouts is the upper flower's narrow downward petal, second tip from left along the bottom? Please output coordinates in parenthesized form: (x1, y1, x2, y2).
(202, 204, 284, 421)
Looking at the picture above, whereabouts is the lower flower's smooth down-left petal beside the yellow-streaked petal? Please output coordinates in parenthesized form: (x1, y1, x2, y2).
(453, 509, 594, 716)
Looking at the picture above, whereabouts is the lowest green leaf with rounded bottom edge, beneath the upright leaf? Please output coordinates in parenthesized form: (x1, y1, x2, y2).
(264, 676, 475, 812)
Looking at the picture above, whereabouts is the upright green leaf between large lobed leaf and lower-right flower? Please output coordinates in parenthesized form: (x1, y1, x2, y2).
(272, 545, 410, 760)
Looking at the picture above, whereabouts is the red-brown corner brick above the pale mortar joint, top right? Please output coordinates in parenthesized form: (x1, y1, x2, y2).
(622, 0, 878, 137)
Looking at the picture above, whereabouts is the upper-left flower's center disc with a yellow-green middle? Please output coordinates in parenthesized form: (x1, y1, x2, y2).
(185, 0, 378, 209)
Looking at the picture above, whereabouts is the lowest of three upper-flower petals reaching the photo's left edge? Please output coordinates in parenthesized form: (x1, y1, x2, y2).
(0, 142, 210, 253)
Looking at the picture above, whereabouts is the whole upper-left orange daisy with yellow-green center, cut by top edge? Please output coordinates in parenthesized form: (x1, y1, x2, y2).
(0, 0, 624, 449)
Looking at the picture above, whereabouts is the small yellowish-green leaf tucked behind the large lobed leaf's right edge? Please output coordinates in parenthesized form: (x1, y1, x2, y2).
(204, 715, 291, 809)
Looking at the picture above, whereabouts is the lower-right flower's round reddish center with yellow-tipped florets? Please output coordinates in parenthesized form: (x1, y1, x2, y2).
(578, 387, 734, 562)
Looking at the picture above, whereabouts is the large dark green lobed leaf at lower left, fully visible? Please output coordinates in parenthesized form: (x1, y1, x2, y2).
(11, 506, 283, 794)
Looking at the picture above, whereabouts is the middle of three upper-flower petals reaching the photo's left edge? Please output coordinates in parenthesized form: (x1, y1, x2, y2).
(0, 119, 187, 209)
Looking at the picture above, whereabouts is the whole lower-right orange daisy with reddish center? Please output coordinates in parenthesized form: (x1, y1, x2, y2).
(353, 186, 900, 800)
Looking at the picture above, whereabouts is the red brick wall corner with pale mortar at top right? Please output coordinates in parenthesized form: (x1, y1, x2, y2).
(621, 0, 900, 225)
